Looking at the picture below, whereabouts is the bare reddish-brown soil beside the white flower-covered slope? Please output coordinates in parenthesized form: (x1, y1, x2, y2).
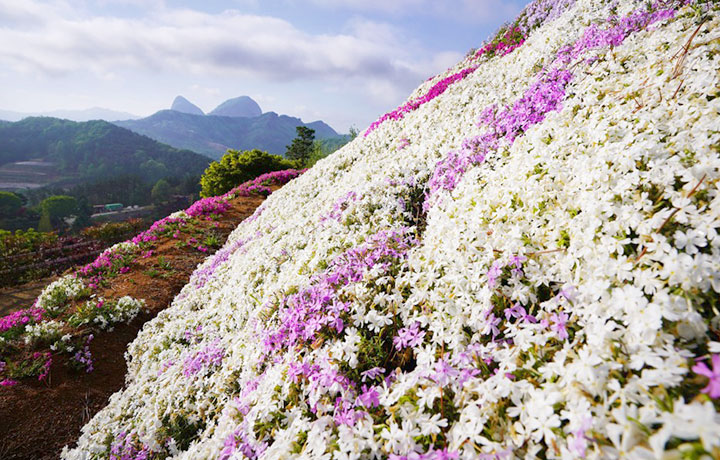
(0, 192, 264, 460)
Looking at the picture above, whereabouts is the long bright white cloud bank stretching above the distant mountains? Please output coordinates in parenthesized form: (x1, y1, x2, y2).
(0, 0, 444, 88)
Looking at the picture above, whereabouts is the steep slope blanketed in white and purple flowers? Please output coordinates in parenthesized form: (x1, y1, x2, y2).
(64, 0, 720, 459)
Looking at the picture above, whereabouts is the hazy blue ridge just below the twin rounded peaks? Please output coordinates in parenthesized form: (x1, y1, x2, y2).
(115, 104, 340, 159)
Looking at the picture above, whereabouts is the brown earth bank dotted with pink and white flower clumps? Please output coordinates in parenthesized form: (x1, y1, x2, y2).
(0, 170, 301, 460)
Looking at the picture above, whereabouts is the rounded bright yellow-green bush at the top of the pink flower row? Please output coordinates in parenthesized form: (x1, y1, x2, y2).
(200, 149, 294, 197)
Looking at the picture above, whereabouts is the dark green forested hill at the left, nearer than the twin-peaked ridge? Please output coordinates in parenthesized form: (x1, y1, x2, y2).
(0, 117, 210, 181)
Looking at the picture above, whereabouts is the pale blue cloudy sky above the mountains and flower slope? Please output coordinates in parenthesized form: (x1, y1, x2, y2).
(0, 0, 527, 132)
